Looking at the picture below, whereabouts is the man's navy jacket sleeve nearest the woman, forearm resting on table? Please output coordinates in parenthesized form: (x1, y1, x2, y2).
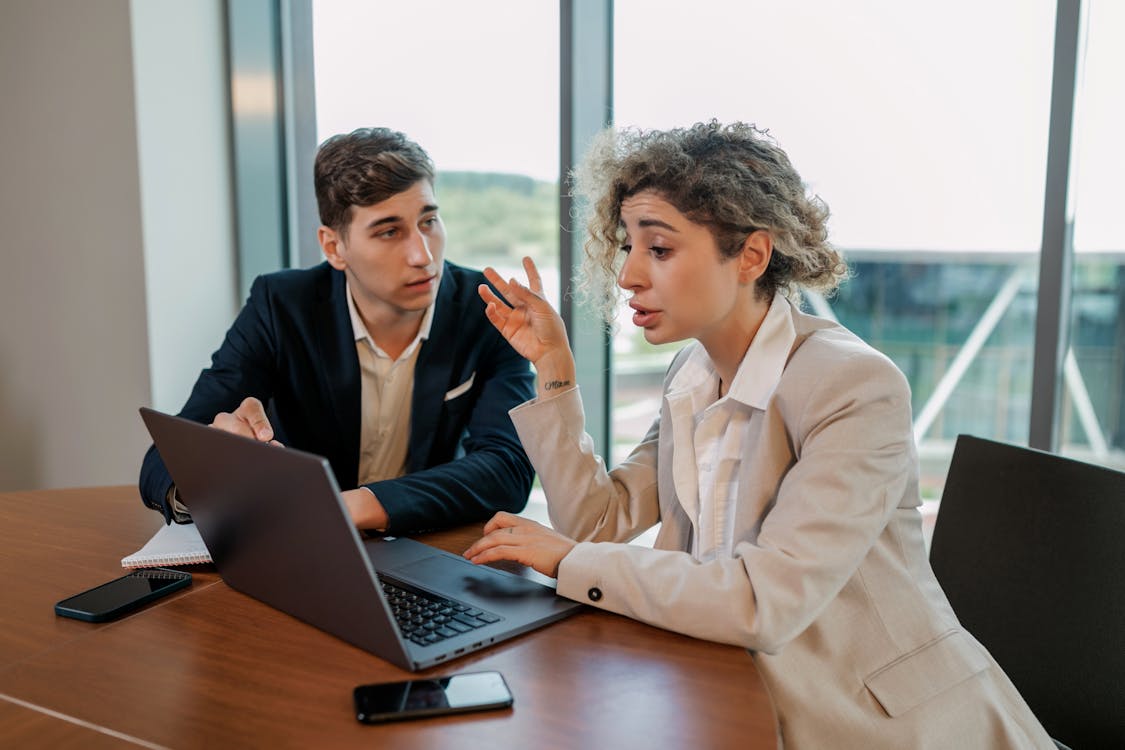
(367, 323, 534, 533)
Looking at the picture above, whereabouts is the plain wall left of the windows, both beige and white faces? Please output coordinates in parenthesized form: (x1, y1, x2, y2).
(0, 0, 236, 490)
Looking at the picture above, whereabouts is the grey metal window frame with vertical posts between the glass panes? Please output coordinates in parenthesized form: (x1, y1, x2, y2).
(235, 0, 1087, 463)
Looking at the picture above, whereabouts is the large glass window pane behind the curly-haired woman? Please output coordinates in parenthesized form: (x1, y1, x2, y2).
(613, 0, 1057, 539)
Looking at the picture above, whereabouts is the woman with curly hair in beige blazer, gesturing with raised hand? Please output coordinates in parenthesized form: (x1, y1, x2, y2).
(466, 121, 1054, 749)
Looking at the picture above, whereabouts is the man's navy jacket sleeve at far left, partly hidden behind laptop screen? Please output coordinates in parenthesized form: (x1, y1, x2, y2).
(138, 278, 278, 523)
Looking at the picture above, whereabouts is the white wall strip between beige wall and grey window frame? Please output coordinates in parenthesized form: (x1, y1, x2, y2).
(132, 0, 237, 413)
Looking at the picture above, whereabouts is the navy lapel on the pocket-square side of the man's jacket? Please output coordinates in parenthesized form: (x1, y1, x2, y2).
(407, 265, 461, 471)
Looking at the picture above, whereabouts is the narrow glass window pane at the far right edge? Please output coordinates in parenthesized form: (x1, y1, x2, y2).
(1059, 0, 1125, 469)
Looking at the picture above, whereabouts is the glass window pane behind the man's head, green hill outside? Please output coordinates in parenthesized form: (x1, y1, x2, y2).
(313, 0, 560, 521)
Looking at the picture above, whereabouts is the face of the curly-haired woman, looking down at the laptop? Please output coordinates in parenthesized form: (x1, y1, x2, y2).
(618, 190, 754, 350)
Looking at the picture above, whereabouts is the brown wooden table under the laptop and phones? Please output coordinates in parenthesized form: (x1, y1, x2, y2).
(0, 487, 776, 750)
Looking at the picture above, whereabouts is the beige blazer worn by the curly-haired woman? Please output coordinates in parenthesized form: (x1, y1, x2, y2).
(511, 308, 1054, 750)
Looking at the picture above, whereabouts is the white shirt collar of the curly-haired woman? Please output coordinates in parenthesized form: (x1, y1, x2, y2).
(668, 295, 797, 410)
